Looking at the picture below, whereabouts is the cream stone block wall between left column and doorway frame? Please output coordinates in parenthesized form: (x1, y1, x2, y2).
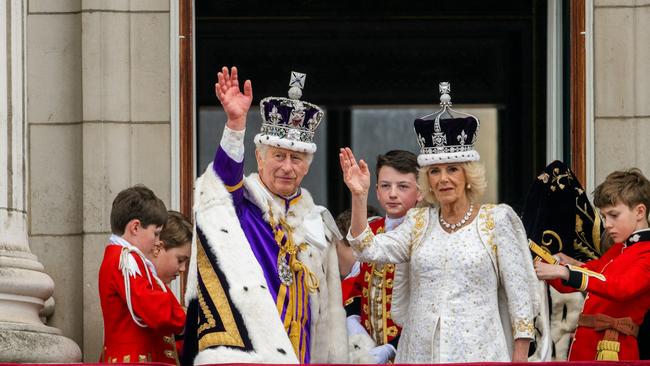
(26, 0, 171, 362)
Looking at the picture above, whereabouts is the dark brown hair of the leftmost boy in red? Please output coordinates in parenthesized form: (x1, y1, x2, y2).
(111, 184, 167, 235)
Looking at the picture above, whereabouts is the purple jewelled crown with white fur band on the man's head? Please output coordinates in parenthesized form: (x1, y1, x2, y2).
(255, 71, 325, 153)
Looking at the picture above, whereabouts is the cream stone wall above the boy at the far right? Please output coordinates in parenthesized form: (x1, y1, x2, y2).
(593, 0, 650, 184)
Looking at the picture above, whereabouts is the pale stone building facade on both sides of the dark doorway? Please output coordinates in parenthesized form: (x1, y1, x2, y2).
(0, 0, 650, 362)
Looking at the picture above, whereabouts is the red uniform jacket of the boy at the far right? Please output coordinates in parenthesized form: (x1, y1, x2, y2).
(549, 229, 650, 361)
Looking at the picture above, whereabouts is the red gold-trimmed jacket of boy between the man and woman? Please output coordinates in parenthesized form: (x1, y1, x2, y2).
(344, 218, 401, 348)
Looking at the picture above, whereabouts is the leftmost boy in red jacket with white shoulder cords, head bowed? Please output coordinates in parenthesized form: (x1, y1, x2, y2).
(99, 185, 185, 364)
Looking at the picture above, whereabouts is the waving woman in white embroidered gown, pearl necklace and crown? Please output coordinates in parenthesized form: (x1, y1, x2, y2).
(339, 84, 540, 363)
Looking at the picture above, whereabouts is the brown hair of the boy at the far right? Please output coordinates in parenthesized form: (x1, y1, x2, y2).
(594, 168, 650, 218)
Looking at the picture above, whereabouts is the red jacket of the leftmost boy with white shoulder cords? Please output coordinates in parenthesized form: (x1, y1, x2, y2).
(99, 245, 185, 364)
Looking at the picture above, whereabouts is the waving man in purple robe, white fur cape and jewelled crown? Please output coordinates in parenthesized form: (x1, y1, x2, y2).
(181, 67, 348, 365)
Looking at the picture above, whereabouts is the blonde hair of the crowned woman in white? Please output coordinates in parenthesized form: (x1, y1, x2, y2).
(418, 161, 487, 206)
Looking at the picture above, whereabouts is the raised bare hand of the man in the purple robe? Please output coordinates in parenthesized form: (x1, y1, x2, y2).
(214, 66, 253, 131)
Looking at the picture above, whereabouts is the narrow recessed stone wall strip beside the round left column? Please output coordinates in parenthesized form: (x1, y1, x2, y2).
(25, 1, 83, 349)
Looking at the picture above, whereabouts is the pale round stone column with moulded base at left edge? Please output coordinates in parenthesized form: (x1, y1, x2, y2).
(0, 0, 81, 362)
